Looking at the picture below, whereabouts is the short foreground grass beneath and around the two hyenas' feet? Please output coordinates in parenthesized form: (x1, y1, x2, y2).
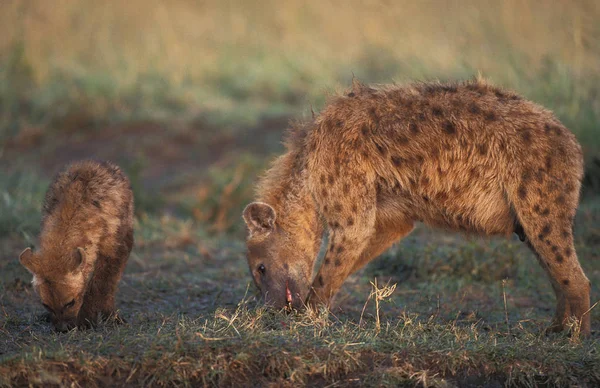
(0, 175, 600, 386)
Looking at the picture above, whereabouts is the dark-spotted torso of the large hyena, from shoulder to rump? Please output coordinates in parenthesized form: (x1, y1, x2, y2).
(306, 82, 583, 235)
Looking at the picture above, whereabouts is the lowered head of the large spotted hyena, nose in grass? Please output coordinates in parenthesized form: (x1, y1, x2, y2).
(243, 202, 319, 309)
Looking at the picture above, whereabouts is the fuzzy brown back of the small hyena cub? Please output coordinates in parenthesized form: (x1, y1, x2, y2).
(41, 160, 133, 266)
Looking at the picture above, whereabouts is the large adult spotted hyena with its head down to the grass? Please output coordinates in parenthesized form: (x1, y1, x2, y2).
(243, 80, 590, 333)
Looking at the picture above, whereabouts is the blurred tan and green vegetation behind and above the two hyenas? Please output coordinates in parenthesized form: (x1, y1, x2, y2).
(0, 0, 600, 233)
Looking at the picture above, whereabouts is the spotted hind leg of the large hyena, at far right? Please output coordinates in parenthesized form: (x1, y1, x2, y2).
(513, 186, 590, 335)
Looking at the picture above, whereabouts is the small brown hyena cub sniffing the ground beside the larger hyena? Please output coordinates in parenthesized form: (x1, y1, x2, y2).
(19, 161, 133, 331)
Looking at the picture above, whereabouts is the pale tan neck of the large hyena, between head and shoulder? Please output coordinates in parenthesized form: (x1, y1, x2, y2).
(258, 151, 323, 253)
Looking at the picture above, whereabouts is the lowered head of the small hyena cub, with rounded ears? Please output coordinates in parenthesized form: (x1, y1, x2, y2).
(19, 248, 86, 332)
